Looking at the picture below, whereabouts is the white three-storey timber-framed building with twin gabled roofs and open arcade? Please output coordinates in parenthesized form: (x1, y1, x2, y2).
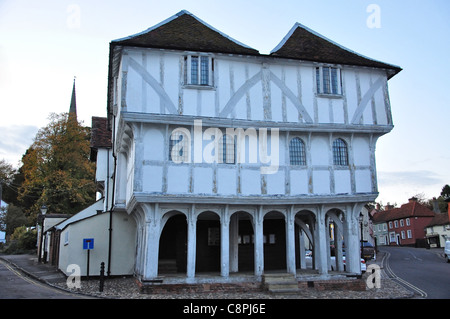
(108, 11, 401, 283)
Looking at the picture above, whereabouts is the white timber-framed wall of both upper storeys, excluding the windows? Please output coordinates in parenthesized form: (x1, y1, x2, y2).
(111, 48, 392, 205)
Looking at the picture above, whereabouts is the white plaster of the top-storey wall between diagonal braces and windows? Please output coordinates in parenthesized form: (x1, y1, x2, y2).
(118, 48, 388, 125)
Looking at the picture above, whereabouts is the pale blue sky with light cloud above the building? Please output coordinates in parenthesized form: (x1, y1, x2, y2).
(0, 0, 450, 204)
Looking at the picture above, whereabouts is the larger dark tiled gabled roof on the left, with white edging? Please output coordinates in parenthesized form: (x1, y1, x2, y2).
(111, 10, 259, 55)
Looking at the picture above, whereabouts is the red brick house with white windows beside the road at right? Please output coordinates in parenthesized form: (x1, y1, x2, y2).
(373, 197, 435, 247)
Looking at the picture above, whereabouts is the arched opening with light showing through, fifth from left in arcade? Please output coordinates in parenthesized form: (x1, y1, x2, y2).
(295, 210, 317, 272)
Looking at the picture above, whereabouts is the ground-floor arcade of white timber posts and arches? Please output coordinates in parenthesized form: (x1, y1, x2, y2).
(131, 202, 364, 283)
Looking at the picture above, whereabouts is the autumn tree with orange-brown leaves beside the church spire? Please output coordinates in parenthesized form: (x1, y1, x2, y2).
(18, 113, 95, 217)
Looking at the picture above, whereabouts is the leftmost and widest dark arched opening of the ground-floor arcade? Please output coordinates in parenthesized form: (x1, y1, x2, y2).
(158, 211, 187, 274)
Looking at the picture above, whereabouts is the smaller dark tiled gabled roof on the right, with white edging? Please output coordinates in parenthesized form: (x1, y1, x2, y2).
(270, 23, 402, 77)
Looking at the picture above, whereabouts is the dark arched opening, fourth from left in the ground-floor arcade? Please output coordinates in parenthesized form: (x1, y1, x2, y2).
(263, 211, 287, 271)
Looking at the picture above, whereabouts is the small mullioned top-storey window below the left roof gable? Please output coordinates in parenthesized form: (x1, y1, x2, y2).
(184, 55, 214, 87)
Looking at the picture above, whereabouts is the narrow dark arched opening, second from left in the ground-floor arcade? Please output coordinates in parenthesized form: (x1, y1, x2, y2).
(195, 211, 220, 273)
